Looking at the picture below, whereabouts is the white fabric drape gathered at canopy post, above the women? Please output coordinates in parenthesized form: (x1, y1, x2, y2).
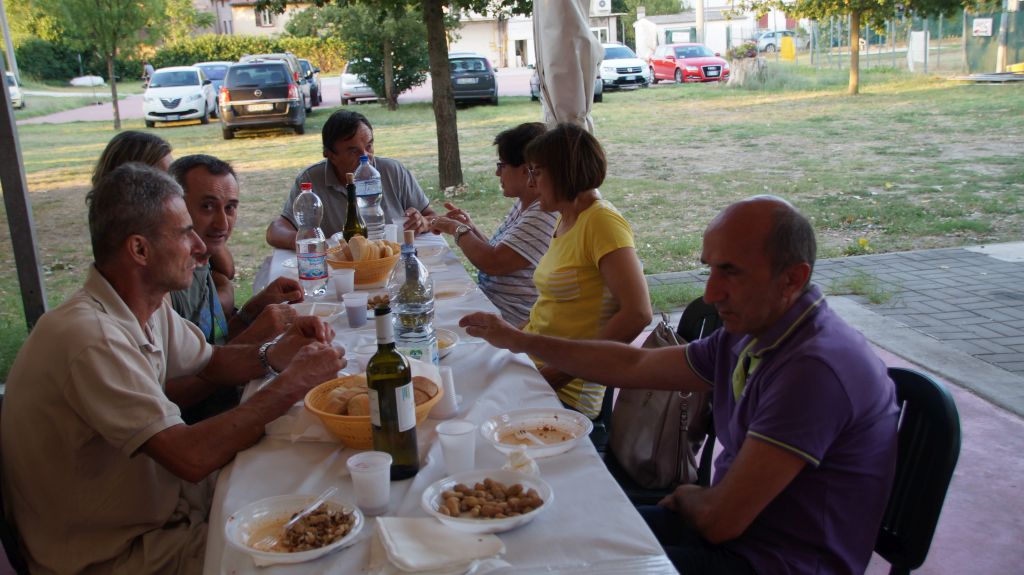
(534, 0, 604, 132)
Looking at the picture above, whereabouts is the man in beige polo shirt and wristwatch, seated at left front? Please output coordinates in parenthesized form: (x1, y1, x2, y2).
(2, 164, 345, 573)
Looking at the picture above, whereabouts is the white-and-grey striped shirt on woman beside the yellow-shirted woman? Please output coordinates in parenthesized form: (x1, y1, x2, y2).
(477, 200, 557, 325)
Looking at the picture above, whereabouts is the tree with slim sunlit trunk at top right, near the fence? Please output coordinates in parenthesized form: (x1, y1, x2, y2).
(737, 0, 1000, 95)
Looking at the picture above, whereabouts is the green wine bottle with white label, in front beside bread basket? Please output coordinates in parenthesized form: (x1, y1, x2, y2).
(367, 305, 420, 481)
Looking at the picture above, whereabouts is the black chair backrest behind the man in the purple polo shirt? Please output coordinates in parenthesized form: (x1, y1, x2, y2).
(874, 367, 961, 575)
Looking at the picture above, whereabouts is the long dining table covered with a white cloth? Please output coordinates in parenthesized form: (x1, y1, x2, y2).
(204, 234, 676, 575)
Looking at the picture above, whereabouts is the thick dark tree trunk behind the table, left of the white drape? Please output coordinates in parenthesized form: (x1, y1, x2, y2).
(422, 0, 462, 190)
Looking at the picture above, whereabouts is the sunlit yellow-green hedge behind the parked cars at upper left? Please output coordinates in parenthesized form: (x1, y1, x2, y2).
(152, 34, 345, 72)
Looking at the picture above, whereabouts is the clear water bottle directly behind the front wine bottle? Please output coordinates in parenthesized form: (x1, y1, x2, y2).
(387, 230, 438, 365)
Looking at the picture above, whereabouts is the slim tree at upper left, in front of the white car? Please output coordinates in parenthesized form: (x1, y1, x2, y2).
(36, 0, 165, 130)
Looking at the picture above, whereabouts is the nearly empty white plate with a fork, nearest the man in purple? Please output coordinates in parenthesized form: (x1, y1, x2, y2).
(480, 408, 594, 459)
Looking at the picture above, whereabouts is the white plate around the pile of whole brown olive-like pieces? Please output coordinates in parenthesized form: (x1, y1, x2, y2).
(420, 470, 555, 533)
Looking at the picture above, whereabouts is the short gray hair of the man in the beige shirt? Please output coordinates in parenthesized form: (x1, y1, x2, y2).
(85, 162, 183, 264)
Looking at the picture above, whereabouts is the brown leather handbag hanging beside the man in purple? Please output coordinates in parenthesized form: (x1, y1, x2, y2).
(609, 315, 712, 489)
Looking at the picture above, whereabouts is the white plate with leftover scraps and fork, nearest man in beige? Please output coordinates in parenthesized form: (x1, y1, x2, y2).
(224, 495, 364, 565)
